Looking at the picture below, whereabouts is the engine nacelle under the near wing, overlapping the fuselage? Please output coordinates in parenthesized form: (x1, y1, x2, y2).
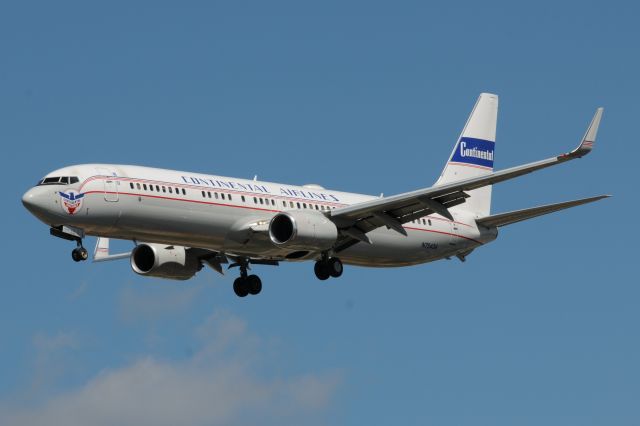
(269, 210, 338, 251)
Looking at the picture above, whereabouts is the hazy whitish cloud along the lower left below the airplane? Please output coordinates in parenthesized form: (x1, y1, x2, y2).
(0, 314, 340, 426)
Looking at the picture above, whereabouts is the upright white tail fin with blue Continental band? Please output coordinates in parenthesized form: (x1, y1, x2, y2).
(436, 93, 498, 217)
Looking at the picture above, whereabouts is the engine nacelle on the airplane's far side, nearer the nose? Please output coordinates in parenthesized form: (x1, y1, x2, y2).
(131, 244, 202, 280)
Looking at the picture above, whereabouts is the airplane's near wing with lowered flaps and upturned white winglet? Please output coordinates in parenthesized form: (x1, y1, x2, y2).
(328, 108, 603, 251)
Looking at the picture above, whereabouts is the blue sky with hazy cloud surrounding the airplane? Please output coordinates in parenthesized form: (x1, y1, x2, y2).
(0, 1, 640, 425)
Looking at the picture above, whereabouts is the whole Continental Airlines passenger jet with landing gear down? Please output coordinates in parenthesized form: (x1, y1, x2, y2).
(22, 93, 609, 297)
